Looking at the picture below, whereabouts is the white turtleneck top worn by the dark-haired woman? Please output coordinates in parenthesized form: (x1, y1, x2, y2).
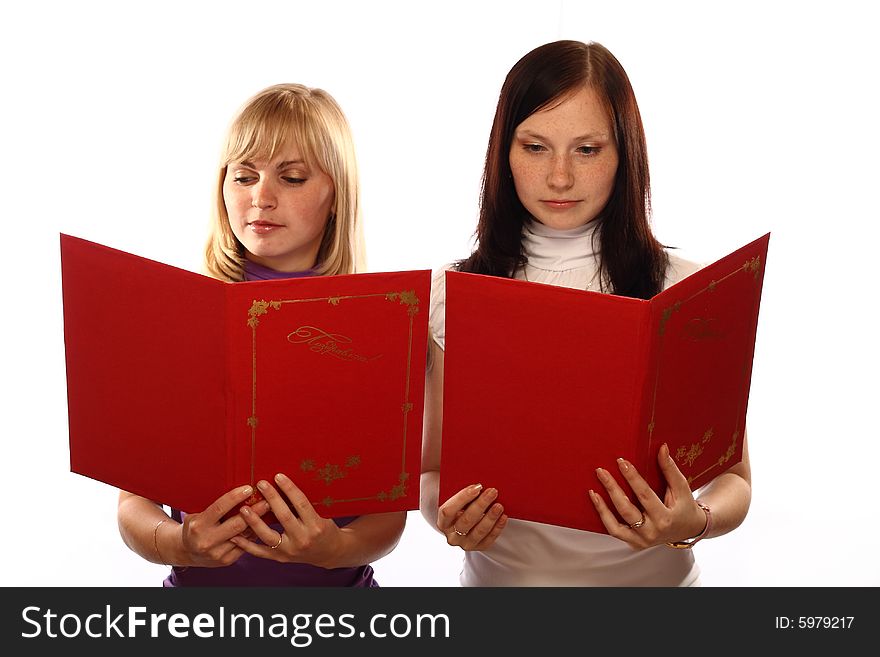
(430, 221, 701, 586)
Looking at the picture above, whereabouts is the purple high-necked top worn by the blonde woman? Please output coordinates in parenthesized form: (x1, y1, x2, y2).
(162, 260, 379, 587)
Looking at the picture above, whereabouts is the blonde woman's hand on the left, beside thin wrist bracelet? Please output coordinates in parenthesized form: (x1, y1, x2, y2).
(174, 486, 269, 568)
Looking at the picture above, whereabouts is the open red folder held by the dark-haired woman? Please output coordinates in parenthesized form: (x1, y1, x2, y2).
(440, 234, 770, 533)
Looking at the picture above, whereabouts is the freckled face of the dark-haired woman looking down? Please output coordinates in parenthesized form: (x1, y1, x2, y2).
(510, 87, 618, 230)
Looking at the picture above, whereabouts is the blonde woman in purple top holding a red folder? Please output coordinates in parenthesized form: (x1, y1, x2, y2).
(118, 84, 406, 587)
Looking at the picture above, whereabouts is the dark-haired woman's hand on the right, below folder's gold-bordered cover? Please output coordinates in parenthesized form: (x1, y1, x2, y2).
(590, 444, 706, 550)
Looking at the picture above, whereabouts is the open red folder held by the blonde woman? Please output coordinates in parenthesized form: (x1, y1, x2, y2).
(61, 235, 430, 517)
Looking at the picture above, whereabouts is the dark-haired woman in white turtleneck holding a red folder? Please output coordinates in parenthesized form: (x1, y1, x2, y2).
(421, 41, 751, 586)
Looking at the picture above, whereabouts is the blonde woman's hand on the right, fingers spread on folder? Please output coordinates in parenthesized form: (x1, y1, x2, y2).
(230, 473, 341, 566)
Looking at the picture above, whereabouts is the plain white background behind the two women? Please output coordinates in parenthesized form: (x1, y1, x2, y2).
(0, 0, 880, 586)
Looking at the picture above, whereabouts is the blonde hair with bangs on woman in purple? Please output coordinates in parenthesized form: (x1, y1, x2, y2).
(205, 84, 364, 281)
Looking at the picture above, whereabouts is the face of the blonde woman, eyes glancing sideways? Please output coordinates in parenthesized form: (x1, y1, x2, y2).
(223, 145, 334, 272)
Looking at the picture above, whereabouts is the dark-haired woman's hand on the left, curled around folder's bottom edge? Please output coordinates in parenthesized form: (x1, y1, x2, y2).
(437, 484, 507, 551)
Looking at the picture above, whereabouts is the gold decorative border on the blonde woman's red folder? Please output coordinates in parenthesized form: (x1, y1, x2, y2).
(241, 290, 419, 507)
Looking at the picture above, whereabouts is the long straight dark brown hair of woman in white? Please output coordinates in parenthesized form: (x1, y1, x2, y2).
(458, 41, 668, 299)
